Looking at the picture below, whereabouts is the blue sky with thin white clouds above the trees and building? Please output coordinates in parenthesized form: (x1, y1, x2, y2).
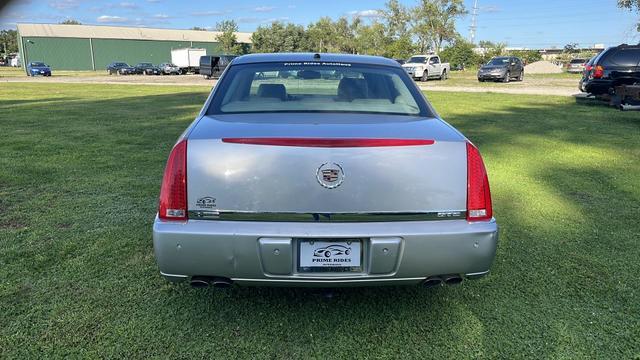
(0, 0, 640, 48)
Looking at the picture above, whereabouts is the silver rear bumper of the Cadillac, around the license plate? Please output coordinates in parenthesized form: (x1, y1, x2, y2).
(153, 218, 498, 287)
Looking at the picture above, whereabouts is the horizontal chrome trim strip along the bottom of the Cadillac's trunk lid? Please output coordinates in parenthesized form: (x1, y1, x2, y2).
(189, 210, 467, 222)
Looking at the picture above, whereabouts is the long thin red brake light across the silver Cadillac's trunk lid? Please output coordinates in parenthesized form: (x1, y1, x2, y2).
(222, 138, 435, 148)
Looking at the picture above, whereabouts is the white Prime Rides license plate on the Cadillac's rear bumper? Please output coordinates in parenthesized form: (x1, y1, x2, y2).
(298, 239, 362, 272)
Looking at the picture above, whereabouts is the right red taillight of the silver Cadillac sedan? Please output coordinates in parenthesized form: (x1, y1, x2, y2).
(467, 142, 493, 221)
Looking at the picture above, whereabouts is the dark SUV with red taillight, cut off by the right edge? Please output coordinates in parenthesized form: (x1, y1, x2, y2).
(583, 44, 640, 95)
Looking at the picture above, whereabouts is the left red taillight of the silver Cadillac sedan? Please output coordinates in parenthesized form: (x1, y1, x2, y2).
(158, 139, 187, 220)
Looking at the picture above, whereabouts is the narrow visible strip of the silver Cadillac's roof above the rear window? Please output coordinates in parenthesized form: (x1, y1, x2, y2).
(233, 53, 400, 67)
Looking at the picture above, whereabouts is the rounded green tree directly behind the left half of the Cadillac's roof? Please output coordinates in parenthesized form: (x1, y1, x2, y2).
(251, 22, 308, 52)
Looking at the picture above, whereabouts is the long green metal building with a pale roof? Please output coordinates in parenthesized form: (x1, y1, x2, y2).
(17, 24, 251, 71)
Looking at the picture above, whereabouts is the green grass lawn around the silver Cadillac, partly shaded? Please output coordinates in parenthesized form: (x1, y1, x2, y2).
(0, 83, 640, 359)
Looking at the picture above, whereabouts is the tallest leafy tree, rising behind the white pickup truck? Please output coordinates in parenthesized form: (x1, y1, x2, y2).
(412, 0, 467, 52)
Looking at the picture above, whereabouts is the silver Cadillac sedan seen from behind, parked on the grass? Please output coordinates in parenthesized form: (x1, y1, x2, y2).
(153, 54, 498, 287)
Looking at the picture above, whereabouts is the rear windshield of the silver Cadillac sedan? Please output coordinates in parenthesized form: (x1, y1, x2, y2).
(207, 62, 432, 116)
